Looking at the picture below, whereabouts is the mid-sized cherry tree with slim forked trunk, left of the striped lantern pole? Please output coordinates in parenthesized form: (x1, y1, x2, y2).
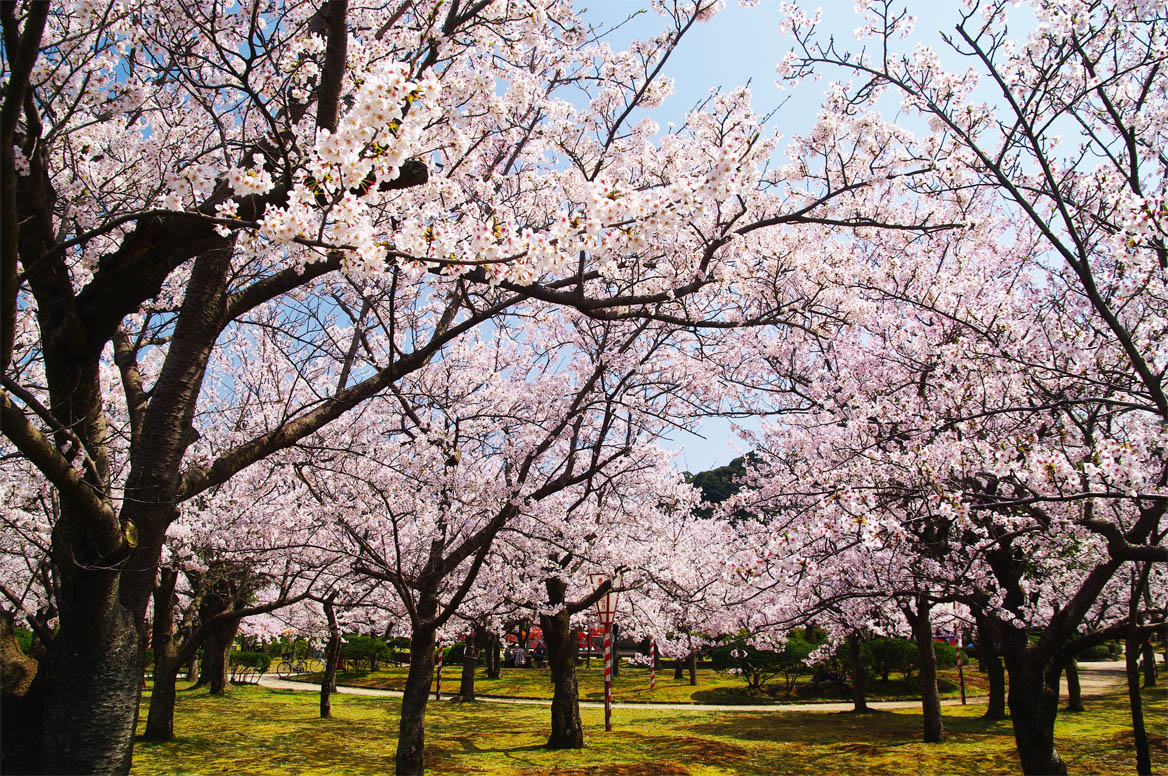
(286, 311, 714, 774)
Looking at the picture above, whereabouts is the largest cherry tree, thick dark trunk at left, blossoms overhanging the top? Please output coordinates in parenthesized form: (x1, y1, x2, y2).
(0, 0, 941, 772)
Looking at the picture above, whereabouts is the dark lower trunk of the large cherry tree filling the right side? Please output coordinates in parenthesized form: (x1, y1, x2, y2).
(1001, 624, 1066, 776)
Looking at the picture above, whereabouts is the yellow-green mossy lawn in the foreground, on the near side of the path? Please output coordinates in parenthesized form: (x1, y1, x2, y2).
(133, 687, 1168, 776)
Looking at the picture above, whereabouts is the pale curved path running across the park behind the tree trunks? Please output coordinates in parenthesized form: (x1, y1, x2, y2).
(259, 660, 1126, 712)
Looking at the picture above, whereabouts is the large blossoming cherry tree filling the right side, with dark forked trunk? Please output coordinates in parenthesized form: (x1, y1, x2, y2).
(710, 2, 1168, 772)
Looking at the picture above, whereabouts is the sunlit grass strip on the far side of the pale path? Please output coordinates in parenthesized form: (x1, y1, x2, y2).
(305, 660, 987, 705)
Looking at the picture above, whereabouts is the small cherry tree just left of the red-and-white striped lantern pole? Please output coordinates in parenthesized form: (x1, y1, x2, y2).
(488, 448, 722, 749)
